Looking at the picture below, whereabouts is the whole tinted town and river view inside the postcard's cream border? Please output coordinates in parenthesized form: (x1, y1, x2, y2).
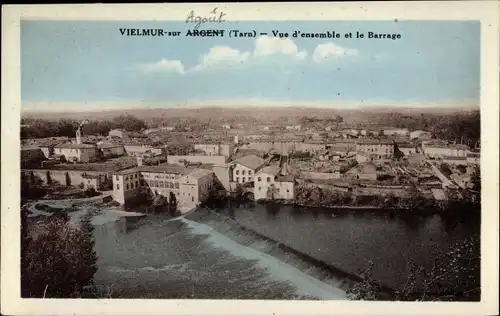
(20, 21, 481, 302)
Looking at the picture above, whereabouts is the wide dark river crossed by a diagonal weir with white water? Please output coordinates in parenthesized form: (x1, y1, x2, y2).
(86, 203, 480, 300)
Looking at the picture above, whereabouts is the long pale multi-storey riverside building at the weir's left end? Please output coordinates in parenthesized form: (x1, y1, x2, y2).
(113, 165, 214, 207)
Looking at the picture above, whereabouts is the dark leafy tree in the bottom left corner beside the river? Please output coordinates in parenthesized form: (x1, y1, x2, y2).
(21, 208, 97, 298)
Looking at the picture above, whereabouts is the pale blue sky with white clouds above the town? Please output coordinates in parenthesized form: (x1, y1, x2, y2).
(21, 21, 480, 110)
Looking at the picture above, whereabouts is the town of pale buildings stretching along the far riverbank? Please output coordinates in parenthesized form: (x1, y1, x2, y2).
(21, 116, 480, 212)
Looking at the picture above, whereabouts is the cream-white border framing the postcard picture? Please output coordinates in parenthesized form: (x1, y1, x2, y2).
(1, 1, 500, 316)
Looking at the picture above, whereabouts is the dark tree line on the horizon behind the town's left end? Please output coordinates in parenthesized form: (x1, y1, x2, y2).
(21, 114, 147, 139)
